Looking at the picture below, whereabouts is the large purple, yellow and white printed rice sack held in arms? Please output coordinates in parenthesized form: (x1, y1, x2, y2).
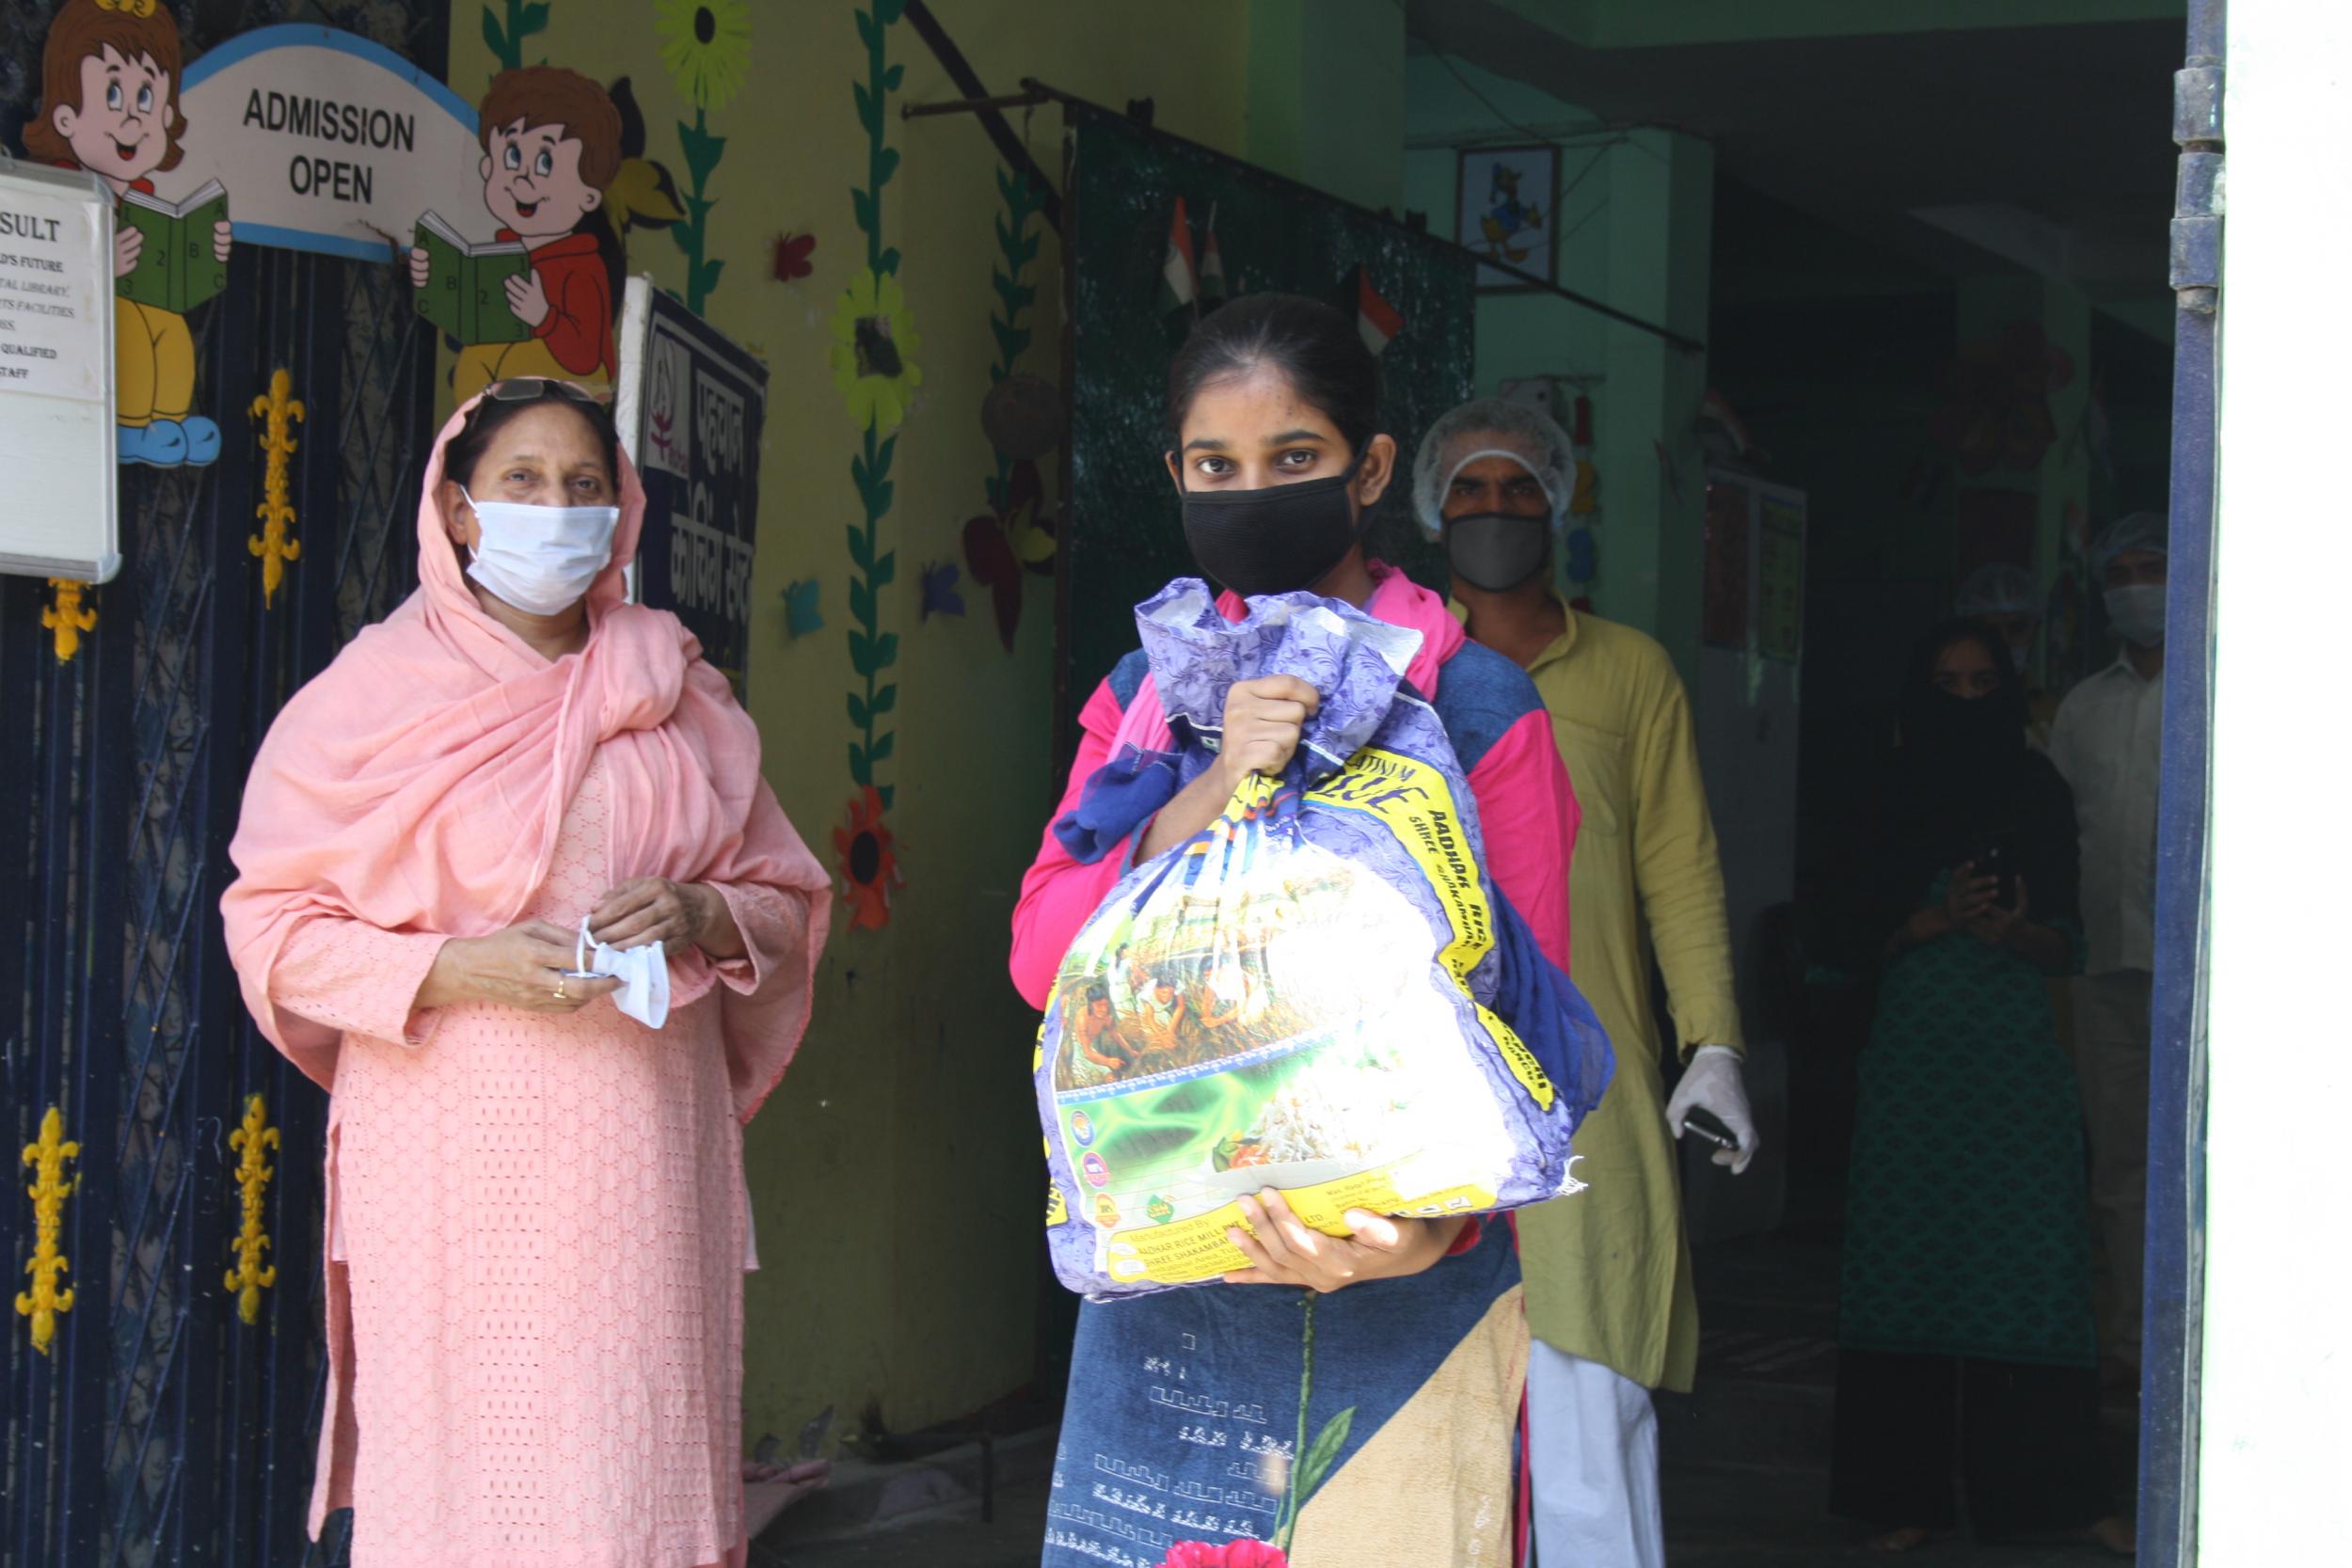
(1035, 578, 1612, 1298)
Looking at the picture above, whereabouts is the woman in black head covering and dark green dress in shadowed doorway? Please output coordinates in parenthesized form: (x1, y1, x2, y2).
(1830, 621, 2131, 1552)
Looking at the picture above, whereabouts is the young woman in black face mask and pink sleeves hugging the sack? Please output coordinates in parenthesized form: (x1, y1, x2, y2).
(1011, 293, 1597, 1568)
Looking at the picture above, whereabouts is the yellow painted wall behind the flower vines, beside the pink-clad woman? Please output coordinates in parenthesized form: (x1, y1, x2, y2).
(450, 0, 1247, 1436)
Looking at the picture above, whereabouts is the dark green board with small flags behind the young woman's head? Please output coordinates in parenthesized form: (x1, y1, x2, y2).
(1057, 105, 1475, 754)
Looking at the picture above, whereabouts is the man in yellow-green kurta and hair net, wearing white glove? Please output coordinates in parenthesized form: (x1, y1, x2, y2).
(1414, 400, 1757, 1568)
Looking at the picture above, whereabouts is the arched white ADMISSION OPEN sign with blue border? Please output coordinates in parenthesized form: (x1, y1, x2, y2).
(181, 24, 497, 265)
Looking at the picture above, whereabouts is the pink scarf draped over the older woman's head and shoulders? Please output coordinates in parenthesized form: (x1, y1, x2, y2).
(221, 397, 833, 1117)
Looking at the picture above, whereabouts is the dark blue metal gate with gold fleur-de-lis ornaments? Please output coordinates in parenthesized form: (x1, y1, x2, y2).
(0, 0, 447, 1568)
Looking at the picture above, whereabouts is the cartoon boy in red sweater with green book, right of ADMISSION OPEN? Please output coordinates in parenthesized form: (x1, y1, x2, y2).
(409, 66, 621, 400)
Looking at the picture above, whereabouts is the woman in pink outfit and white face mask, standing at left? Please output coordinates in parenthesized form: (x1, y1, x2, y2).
(224, 381, 828, 1568)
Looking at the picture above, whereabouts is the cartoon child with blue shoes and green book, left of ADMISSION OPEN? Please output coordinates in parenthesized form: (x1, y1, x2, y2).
(24, 0, 230, 467)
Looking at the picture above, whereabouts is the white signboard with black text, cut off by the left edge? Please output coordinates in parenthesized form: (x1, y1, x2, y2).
(0, 162, 122, 583)
